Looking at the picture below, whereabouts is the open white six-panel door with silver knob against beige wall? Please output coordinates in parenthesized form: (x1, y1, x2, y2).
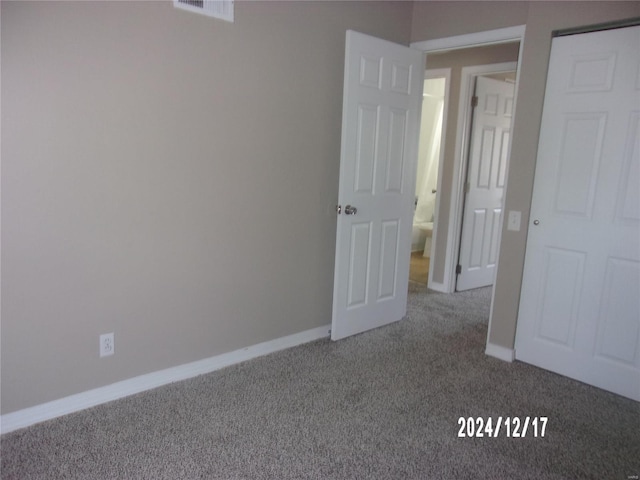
(331, 31, 424, 340)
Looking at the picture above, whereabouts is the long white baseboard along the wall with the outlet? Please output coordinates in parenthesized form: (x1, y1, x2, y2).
(0, 325, 331, 433)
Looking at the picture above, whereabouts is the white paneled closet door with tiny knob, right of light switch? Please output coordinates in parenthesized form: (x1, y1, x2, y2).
(516, 27, 640, 400)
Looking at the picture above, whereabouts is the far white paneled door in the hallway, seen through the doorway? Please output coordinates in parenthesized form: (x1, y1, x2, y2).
(456, 77, 514, 291)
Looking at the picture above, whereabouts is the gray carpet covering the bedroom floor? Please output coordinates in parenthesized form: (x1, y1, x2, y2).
(1, 284, 640, 480)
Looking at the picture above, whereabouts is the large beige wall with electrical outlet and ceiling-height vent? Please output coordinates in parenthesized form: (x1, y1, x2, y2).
(1, 1, 412, 414)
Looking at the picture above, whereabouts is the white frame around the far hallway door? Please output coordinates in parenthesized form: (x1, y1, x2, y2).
(452, 62, 518, 292)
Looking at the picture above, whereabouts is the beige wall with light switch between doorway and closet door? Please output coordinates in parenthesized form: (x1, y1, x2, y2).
(412, 1, 640, 348)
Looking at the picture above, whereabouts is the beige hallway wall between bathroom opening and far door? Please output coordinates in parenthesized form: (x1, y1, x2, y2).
(427, 43, 520, 283)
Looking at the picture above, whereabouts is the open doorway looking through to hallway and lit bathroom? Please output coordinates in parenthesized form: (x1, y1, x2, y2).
(409, 49, 519, 291)
